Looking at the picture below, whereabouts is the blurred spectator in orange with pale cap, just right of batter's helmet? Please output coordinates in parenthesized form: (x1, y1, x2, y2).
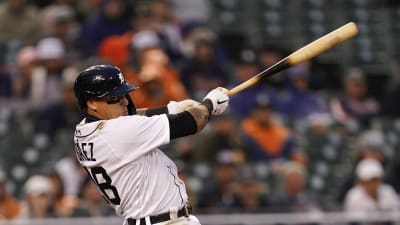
(123, 31, 188, 108)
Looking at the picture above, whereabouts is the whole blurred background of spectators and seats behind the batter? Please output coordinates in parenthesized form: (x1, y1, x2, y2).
(0, 0, 400, 224)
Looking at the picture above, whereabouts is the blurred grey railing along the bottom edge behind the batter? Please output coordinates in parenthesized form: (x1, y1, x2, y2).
(0, 211, 400, 225)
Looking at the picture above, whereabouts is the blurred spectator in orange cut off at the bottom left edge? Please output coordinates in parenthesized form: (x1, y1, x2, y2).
(0, 170, 22, 220)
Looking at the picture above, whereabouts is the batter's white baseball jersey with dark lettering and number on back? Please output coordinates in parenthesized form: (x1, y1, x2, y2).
(74, 115, 187, 219)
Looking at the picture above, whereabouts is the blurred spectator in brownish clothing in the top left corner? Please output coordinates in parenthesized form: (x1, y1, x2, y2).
(0, 0, 41, 46)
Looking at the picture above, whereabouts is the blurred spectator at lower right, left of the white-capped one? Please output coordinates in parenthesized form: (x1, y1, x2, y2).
(270, 162, 320, 213)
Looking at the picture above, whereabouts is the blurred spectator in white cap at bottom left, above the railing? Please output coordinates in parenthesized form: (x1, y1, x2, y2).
(20, 175, 55, 218)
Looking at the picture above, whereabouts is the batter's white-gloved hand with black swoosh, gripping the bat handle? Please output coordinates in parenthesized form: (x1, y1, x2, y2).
(203, 87, 229, 115)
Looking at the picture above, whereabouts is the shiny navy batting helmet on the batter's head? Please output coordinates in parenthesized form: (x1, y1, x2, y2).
(74, 65, 138, 114)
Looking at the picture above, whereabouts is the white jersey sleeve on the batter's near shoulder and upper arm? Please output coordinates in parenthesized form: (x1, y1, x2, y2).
(102, 115, 170, 160)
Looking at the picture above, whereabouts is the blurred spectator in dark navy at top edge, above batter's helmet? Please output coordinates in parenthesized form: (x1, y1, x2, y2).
(82, 0, 132, 55)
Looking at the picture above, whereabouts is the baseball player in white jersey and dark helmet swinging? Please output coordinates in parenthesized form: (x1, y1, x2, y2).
(74, 65, 229, 225)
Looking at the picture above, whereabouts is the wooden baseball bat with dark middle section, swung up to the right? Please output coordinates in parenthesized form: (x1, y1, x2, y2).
(227, 22, 358, 96)
